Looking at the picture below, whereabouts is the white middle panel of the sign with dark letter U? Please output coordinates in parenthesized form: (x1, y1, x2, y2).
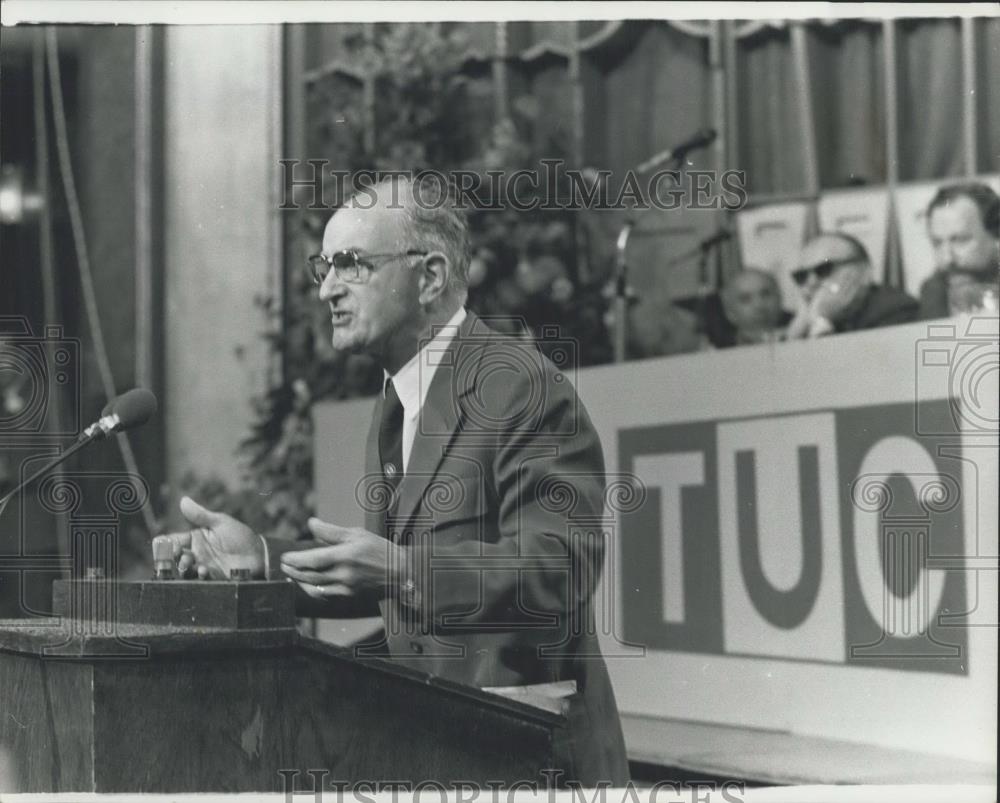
(718, 413, 845, 663)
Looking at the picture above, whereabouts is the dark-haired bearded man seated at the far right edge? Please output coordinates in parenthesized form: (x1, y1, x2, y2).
(920, 182, 1000, 319)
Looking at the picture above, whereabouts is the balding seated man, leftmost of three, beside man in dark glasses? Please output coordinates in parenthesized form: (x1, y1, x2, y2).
(715, 268, 792, 348)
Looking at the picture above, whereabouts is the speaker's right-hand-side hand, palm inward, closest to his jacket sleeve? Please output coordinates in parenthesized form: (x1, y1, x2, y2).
(281, 518, 403, 599)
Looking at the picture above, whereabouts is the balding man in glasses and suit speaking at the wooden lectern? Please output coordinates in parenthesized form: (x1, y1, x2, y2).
(165, 177, 628, 786)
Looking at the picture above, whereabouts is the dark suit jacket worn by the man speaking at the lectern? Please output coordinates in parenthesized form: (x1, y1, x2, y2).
(272, 313, 628, 785)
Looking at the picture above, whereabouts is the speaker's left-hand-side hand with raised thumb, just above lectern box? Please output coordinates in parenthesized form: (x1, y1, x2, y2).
(160, 496, 264, 580)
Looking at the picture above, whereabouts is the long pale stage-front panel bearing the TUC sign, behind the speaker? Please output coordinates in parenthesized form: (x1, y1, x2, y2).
(316, 318, 998, 762)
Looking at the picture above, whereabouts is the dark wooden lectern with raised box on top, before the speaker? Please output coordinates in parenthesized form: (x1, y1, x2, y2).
(0, 580, 567, 793)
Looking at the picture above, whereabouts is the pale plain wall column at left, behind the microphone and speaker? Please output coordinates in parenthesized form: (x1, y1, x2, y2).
(163, 25, 282, 484)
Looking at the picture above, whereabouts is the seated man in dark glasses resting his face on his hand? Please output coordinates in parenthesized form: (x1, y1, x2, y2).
(788, 232, 919, 340)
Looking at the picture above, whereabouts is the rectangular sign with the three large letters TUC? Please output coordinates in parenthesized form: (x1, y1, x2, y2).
(618, 401, 968, 674)
